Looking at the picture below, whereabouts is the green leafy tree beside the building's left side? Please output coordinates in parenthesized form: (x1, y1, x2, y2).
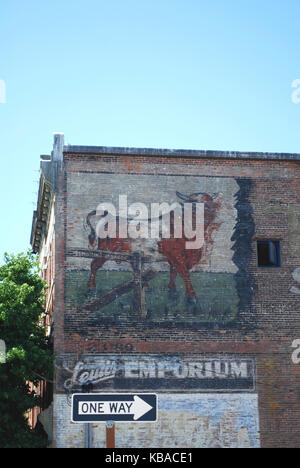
(0, 253, 53, 448)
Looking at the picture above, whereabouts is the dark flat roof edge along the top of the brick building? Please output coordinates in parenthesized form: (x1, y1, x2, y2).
(63, 145, 300, 161)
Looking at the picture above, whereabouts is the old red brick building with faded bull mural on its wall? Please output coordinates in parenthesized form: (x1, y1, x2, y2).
(31, 134, 300, 448)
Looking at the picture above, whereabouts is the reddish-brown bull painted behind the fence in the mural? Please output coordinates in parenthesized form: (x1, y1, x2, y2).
(86, 192, 223, 302)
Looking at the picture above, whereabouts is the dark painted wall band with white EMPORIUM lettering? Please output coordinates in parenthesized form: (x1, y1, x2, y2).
(64, 354, 255, 391)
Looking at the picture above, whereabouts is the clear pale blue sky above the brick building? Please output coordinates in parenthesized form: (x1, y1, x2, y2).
(0, 0, 300, 259)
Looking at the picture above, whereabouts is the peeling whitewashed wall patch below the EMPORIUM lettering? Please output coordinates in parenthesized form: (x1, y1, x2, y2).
(54, 393, 260, 448)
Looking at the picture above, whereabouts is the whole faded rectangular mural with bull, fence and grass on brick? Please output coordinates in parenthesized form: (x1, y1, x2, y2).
(66, 173, 253, 334)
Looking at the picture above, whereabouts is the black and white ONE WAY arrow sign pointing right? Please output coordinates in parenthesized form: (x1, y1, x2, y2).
(72, 393, 157, 423)
